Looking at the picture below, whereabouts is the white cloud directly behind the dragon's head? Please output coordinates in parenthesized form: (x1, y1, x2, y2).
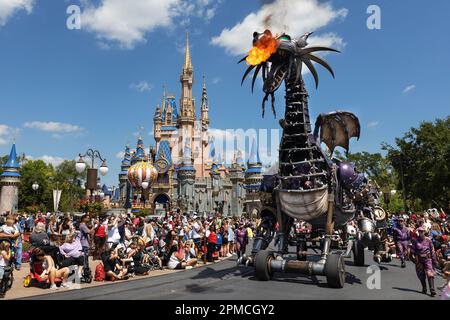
(211, 0, 348, 55)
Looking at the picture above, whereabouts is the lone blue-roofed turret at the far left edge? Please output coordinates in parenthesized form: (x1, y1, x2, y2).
(0, 143, 20, 213)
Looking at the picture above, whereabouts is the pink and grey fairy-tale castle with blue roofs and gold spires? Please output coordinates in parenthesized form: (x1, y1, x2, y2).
(119, 35, 262, 216)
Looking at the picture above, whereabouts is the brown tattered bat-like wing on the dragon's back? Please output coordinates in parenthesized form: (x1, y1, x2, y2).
(314, 111, 361, 153)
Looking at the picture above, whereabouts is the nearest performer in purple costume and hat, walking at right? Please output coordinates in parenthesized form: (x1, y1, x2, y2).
(412, 227, 436, 297)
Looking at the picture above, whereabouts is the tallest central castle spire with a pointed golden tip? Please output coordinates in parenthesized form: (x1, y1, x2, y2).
(178, 33, 196, 161)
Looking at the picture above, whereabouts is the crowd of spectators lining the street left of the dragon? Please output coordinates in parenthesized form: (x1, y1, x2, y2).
(0, 212, 255, 298)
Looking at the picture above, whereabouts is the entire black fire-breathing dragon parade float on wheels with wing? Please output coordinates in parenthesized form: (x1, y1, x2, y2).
(238, 30, 386, 288)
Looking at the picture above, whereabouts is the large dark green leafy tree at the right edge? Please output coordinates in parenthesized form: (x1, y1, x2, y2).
(382, 116, 450, 209)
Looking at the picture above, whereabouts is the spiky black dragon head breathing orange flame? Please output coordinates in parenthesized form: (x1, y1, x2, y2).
(239, 30, 339, 117)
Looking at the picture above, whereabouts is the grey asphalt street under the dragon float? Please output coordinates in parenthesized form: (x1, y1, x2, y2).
(21, 245, 443, 300)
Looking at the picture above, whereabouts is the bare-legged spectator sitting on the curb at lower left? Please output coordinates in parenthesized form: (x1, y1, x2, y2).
(33, 248, 72, 290)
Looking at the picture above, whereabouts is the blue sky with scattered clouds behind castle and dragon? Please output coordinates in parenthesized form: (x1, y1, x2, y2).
(0, 0, 450, 184)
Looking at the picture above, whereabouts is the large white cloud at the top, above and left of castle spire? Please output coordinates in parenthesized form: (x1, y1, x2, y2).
(81, 0, 221, 49)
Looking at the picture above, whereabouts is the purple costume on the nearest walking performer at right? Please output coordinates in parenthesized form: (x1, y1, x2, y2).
(412, 237, 436, 281)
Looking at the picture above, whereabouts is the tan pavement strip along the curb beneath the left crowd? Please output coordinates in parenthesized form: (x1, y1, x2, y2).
(4, 257, 236, 301)
